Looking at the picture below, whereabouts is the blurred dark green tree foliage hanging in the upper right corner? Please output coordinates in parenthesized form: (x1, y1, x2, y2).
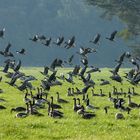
(86, 0, 140, 56)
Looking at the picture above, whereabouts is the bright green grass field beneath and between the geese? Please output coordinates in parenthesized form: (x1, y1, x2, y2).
(0, 68, 140, 140)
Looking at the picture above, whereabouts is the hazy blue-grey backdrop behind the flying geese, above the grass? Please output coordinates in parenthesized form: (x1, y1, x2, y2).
(0, 0, 138, 67)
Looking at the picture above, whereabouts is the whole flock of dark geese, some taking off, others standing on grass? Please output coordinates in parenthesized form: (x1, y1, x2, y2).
(0, 28, 140, 119)
